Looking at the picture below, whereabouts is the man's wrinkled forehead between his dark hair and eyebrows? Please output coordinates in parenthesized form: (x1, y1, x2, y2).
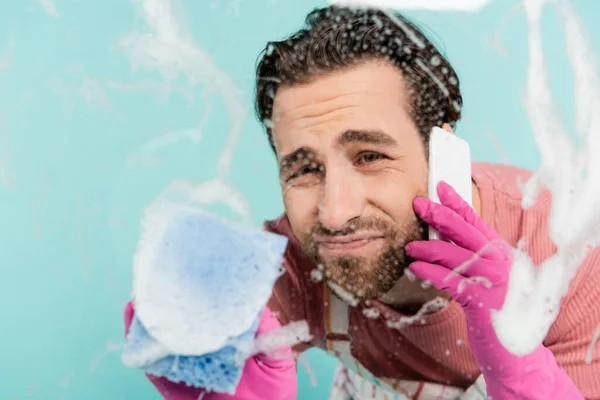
(273, 61, 411, 154)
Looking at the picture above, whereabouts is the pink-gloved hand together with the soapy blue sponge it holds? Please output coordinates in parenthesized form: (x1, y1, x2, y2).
(122, 203, 309, 400)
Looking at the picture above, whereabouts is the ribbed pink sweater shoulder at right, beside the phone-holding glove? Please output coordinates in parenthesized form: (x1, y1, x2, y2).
(473, 163, 600, 344)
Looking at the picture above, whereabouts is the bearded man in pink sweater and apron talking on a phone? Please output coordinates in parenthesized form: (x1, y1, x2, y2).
(124, 3, 600, 399)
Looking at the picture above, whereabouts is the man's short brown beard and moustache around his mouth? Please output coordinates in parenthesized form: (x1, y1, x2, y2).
(299, 214, 427, 301)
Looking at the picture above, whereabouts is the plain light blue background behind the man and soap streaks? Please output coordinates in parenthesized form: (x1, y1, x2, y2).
(0, 0, 600, 400)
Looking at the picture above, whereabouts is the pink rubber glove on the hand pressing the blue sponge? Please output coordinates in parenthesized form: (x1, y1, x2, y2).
(125, 302, 298, 400)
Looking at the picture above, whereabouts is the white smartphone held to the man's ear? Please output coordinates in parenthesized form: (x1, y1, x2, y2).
(428, 127, 473, 239)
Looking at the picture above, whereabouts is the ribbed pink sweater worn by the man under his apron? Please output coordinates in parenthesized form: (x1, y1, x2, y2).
(265, 163, 600, 400)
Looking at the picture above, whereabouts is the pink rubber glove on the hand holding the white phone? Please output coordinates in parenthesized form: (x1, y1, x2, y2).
(406, 182, 583, 400)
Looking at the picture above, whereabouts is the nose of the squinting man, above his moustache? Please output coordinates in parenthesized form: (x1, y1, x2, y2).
(318, 168, 366, 231)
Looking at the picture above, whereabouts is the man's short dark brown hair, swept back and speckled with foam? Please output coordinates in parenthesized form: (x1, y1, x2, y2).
(256, 6, 462, 150)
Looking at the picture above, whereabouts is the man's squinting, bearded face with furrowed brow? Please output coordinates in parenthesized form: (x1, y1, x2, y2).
(273, 62, 427, 300)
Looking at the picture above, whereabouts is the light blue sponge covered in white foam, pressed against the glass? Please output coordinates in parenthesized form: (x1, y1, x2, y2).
(122, 204, 287, 392)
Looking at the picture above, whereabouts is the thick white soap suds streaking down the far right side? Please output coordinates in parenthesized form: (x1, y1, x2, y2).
(492, 1, 600, 355)
